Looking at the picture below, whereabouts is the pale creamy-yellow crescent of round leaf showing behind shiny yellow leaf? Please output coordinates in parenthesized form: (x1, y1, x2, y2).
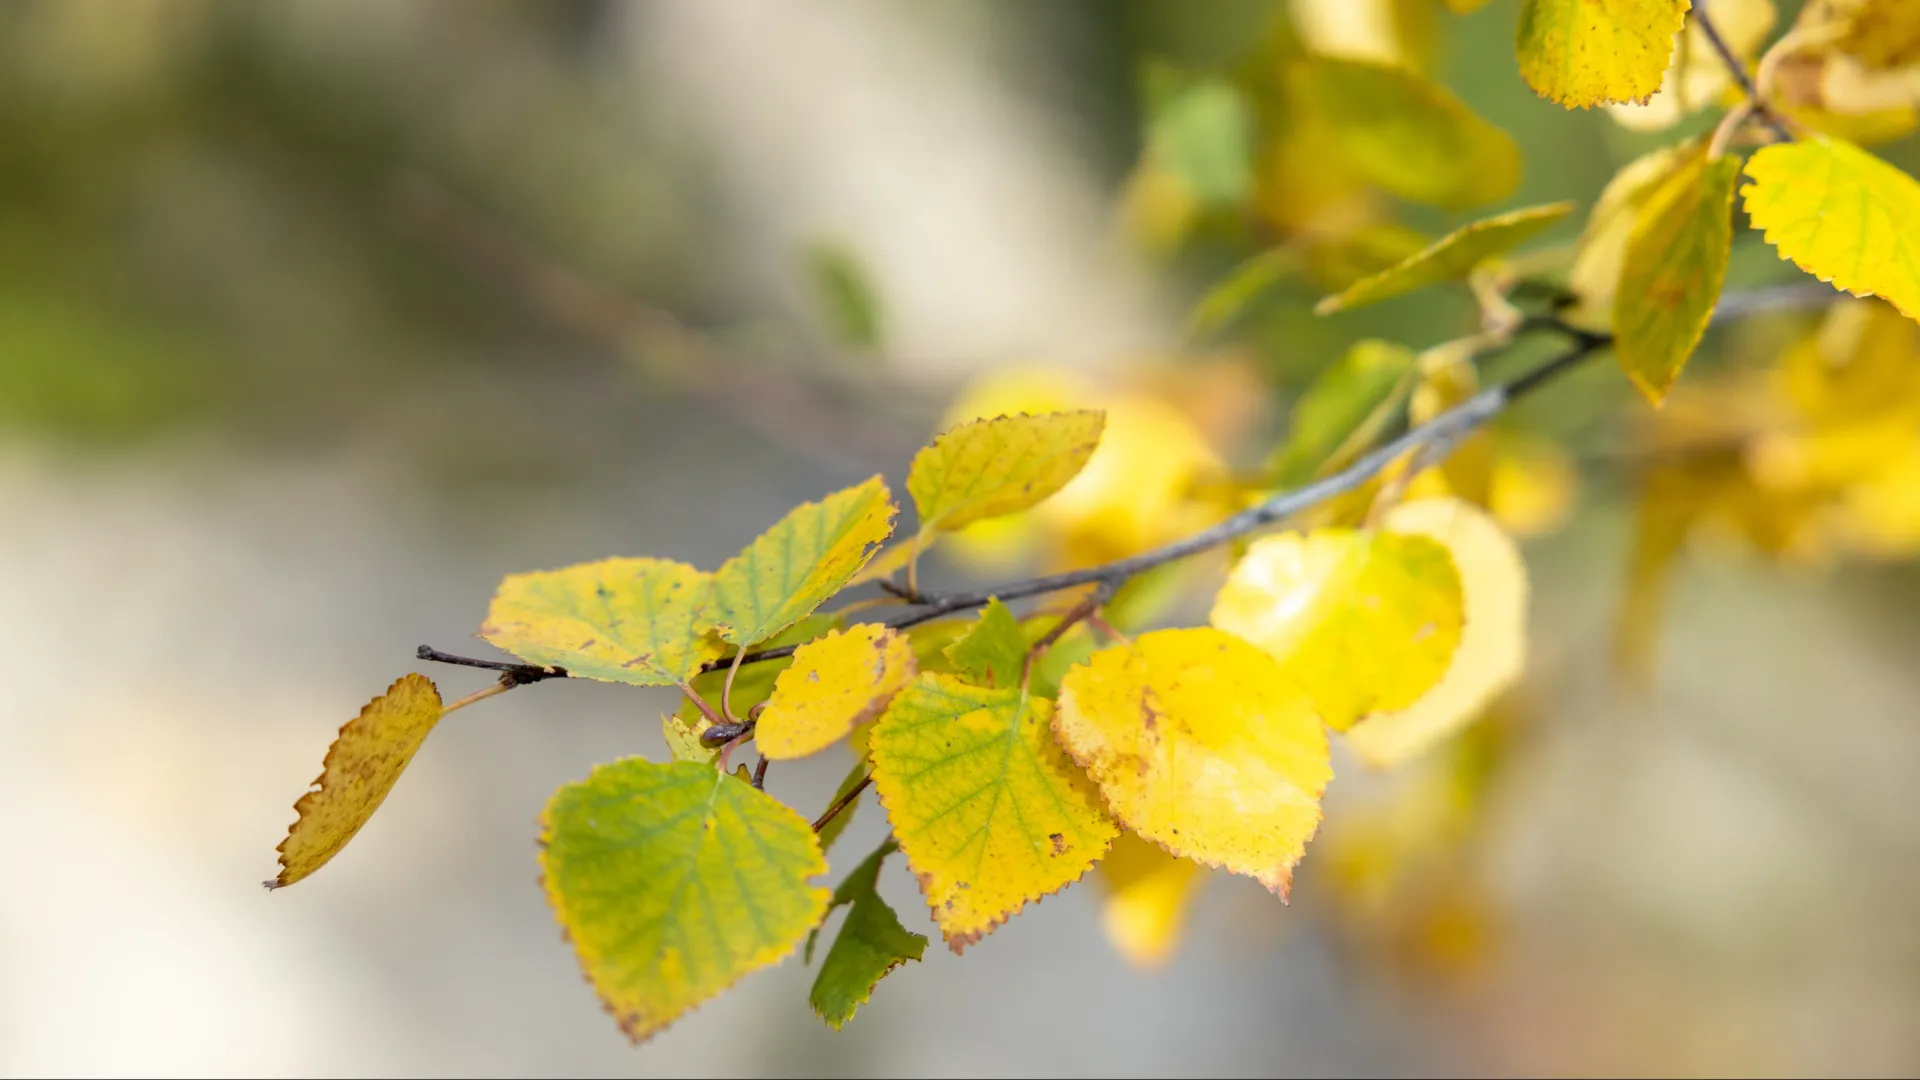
(1346, 500, 1526, 769)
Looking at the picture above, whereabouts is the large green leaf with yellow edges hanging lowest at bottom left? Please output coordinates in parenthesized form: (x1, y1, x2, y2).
(540, 757, 828, 1042)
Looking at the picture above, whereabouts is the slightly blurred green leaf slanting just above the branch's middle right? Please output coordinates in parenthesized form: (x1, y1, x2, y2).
(1269, 340, 1419, 488)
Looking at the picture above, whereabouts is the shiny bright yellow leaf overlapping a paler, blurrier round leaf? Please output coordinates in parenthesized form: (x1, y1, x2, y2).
(1212, 528, 1461, 730)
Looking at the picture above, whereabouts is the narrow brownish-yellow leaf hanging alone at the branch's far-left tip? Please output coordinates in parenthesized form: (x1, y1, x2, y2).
(267, 675, 442, 888)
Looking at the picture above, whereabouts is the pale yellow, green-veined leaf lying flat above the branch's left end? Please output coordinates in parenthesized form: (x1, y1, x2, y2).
(480, 559, 722, 686)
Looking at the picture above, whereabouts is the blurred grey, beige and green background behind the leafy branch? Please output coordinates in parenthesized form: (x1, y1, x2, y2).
(0, 0, 1920, 1076)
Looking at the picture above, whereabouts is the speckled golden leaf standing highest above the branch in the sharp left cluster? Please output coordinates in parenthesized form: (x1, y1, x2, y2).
(906, 409, 1106, 534)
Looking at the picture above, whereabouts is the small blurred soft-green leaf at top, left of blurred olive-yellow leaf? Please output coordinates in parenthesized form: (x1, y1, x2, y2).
(1146, 65, 1254, 208)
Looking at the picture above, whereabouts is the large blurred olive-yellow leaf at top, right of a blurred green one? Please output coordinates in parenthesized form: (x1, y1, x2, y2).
(1294, 56, 1521, 208)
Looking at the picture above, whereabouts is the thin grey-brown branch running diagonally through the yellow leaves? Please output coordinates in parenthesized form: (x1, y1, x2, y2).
(420, 281, 1839, 680)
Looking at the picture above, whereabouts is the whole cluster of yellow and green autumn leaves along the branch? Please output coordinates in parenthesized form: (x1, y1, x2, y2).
(269, 0, 1920, 1040)
